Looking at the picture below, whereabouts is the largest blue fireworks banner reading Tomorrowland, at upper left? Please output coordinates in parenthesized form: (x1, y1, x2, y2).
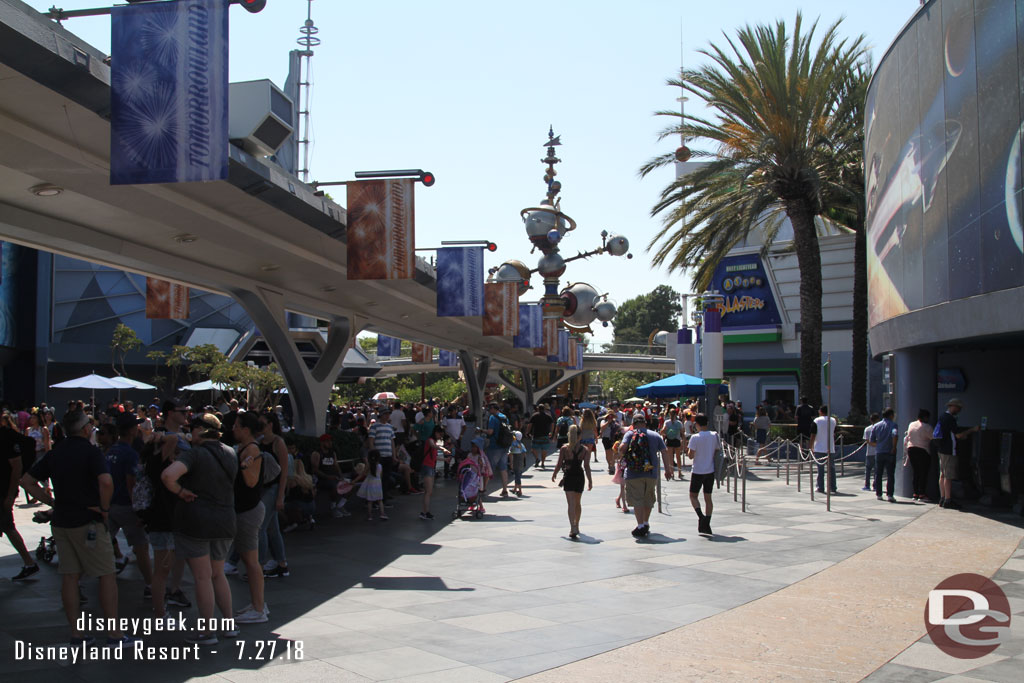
(111, 0, 228, 185)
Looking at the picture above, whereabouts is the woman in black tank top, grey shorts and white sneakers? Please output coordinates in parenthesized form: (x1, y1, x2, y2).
(233, 412, 270, 624)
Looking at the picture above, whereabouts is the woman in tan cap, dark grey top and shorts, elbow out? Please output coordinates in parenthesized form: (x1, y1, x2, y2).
(160, 413, 239, 645)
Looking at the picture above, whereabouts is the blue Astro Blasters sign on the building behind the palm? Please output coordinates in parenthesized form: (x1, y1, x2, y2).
(712, 254, 781, 330)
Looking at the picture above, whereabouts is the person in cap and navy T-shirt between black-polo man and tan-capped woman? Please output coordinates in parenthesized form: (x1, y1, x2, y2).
(106, 413, 153, 600)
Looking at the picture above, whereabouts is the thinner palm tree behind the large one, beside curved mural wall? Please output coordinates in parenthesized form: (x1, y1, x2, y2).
(826, 59, 873, 419)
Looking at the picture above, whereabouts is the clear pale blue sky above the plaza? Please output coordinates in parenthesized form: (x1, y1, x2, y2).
(29, 0, 919, 341)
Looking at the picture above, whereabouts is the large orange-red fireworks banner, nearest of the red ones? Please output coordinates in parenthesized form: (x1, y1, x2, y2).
(346, 178, 416, 280)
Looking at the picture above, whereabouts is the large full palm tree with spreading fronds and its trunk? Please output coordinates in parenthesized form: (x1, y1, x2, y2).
(640, 12, 864, 409)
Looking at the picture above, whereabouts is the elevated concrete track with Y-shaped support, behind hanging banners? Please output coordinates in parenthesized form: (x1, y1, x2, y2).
(0, 0, 561, 433)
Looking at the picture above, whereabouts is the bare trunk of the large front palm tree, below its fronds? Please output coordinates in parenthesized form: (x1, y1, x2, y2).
(785, 199, 821, 405)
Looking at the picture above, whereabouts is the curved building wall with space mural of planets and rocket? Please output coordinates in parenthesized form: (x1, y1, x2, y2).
(864, 0, 1024, 353)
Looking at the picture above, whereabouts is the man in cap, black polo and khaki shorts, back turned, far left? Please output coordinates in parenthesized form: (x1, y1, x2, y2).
(22, 410, 131, 646)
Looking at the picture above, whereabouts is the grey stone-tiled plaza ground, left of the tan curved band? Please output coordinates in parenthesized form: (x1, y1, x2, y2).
(0, 456, 1016, 683)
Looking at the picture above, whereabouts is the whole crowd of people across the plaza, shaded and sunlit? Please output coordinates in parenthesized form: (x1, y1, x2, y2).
(0, 389, 977, 645)
